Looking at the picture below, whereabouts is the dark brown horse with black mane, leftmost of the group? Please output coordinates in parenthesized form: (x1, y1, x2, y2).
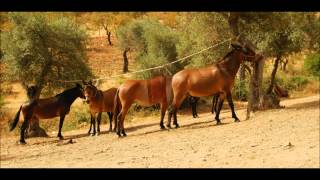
(10, 83, 85, 144)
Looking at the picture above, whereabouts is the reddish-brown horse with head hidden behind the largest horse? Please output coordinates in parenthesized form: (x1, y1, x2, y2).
(114, 76, 172, 137)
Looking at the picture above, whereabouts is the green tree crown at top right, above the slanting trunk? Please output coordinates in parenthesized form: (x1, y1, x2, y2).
(236, 12, 307, 57)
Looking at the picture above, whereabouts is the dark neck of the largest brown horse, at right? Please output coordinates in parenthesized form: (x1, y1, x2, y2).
(218, 51, 242, 78)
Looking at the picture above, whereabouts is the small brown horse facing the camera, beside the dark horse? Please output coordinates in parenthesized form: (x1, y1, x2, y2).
(83, 81, 117, 135)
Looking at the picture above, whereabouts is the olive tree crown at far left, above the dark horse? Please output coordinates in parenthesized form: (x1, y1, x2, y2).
(1, 13, 92, 94)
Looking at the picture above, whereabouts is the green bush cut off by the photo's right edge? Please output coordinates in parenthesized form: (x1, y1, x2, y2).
(304, 53, 320, 77)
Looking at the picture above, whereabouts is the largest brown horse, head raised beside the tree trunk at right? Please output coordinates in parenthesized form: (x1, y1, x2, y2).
(167, 44, 256, 128)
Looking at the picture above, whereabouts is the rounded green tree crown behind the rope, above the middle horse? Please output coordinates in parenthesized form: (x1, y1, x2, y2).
(117, 19, 183, 79)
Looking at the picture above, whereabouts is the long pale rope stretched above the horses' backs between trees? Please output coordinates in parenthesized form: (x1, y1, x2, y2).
(54, 38, 231, 83)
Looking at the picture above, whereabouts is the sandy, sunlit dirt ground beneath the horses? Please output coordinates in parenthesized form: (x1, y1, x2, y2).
(0, 94, 320, 168)
